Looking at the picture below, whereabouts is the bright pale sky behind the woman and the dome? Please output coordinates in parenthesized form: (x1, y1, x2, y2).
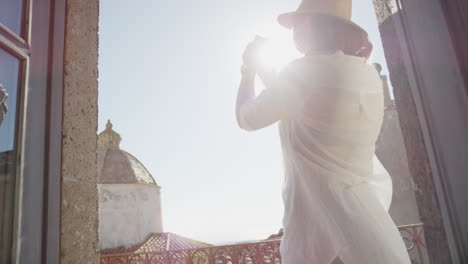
(99, 0, 392, 243)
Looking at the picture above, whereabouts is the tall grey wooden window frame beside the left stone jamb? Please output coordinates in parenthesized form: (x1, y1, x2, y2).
(0, 0, 66, 263)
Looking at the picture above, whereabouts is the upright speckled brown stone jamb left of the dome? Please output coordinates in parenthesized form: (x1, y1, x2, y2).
(60, 0, 99, 264)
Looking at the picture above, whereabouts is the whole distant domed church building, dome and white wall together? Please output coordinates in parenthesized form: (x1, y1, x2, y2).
(98, 121, 163, 249)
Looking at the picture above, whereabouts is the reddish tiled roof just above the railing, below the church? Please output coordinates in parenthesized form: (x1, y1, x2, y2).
(101, 233, 212, 255)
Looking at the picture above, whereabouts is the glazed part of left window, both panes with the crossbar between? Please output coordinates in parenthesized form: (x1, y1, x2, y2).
(0, 0, 29, 263)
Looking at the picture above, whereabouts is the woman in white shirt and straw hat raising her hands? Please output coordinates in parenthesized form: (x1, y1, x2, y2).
(236, 0, 410, 264)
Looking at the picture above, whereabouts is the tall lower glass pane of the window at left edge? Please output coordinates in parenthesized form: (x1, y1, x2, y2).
(0, 49, 20, 263)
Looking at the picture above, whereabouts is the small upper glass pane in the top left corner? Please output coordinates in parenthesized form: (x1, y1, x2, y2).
(0, 0, 23, 35)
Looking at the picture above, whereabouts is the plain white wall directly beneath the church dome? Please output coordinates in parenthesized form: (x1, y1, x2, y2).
(98, 184, 163, 249)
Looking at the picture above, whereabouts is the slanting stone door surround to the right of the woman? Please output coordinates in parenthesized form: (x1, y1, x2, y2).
(373, 0, 451, 263)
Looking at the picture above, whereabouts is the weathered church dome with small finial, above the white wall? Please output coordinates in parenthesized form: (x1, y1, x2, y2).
(98, 121, 158, 186)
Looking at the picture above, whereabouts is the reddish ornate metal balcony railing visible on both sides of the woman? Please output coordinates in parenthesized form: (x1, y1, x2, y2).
(101, 224, 425, 264)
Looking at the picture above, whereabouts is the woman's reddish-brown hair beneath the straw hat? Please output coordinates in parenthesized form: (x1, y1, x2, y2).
(299, 15, 373, 59)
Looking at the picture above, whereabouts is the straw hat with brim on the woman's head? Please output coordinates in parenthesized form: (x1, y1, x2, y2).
(278, 0, 365, 31)
